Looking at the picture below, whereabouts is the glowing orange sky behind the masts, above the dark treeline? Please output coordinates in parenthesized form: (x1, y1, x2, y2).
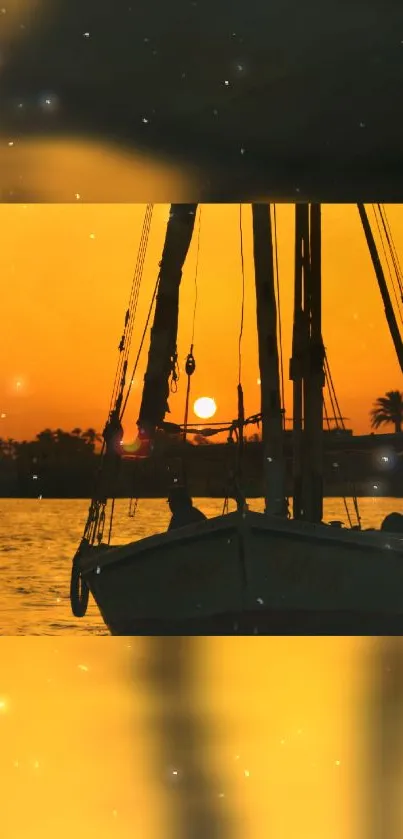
(0, 204, 403, 439)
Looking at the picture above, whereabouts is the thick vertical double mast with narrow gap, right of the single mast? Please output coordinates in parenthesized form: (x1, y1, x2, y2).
(290, 204, 325, 522)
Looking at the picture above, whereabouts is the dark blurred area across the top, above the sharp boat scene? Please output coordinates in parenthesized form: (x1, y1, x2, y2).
(0, 0, 403, 201)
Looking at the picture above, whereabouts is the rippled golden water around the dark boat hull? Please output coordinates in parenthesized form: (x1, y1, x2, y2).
(0, 498, 403, 635)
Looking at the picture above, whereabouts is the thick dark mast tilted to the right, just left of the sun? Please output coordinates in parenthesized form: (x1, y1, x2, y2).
(137, 204, 197, 438)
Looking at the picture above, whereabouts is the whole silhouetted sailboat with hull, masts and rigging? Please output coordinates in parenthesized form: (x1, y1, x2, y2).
(70, 204, 403, 635)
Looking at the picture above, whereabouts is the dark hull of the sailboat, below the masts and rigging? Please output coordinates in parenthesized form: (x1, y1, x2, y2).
(81, 513, 403, 635)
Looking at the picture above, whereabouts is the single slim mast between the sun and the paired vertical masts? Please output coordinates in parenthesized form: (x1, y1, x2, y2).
(252, 204, 287, 516)
